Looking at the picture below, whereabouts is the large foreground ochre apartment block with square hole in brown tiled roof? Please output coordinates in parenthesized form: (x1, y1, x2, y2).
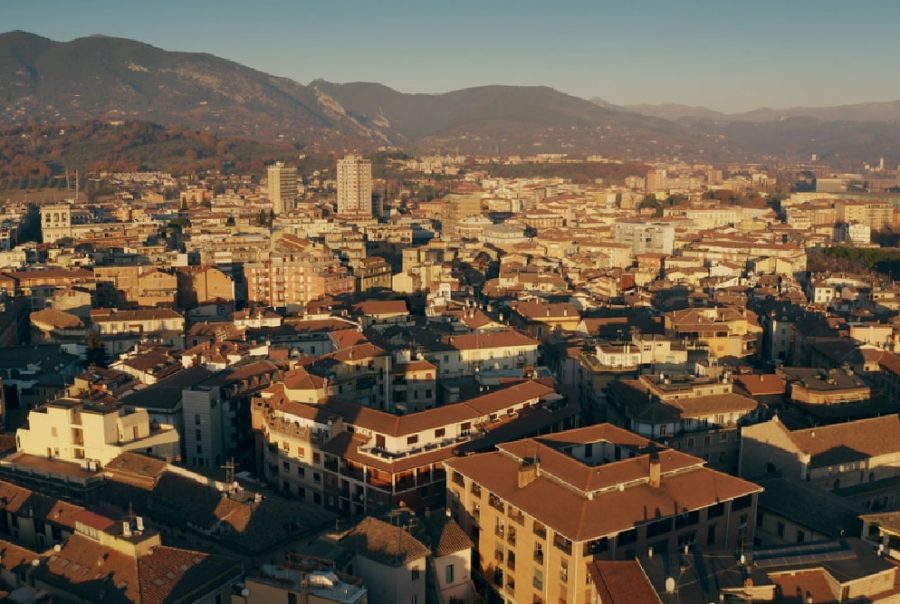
(444, 424, 762, 603)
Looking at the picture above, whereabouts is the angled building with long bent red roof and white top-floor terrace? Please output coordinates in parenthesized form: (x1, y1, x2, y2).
(251, 380, 579, 514)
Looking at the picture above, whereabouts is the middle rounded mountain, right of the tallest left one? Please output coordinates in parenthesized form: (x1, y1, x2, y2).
(310, 80, 702, 155)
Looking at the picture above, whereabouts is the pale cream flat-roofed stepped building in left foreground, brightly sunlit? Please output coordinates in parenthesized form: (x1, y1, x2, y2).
(16, 398, 180, 466)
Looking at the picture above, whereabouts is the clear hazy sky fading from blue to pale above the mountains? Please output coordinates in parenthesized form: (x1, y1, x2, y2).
(0, 0, 900, 111)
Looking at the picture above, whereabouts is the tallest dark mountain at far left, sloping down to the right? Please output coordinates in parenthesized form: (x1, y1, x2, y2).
(0, 31, 381, 148)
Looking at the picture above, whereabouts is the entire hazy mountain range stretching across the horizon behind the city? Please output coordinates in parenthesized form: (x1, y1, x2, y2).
(0, 32, 900, 161)
